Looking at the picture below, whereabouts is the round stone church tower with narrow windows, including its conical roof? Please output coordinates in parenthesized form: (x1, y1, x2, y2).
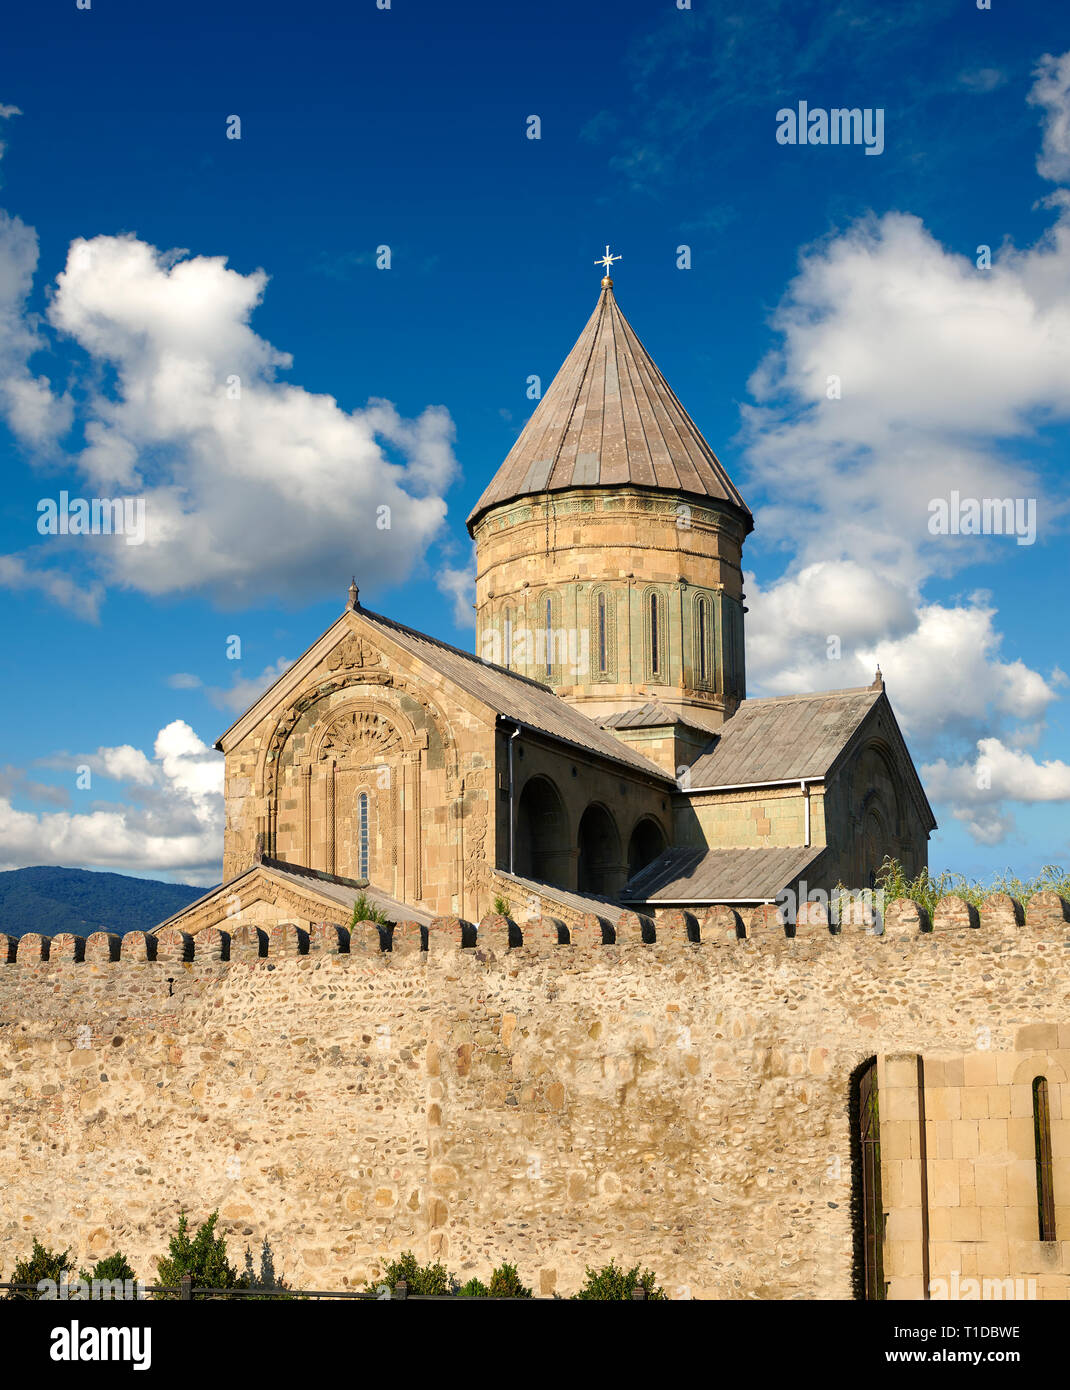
(468, 269, 753, 727)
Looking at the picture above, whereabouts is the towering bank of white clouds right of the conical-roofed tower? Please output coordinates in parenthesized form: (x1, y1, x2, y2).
(742, 54, 1070, 844)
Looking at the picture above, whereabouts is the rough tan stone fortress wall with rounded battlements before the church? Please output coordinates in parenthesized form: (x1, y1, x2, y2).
(0, 899, 1070, 1298)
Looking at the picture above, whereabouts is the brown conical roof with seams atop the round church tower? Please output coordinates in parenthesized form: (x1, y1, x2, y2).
(468, 279, 750, 530)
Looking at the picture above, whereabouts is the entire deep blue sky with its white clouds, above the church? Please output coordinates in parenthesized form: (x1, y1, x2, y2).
(0, 0, 1070, 883)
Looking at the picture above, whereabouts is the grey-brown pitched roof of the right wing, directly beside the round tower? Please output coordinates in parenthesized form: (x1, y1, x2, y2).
(689, 687, 884, 791)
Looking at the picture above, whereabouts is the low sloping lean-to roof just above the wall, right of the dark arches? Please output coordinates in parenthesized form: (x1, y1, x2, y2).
(621, 845, 824, 905)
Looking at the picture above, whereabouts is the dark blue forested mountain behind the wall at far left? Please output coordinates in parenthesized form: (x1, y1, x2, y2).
(0, 865, 207, 937)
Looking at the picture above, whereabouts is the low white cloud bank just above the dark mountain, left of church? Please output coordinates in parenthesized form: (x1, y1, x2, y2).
(0, 720, 224, 884)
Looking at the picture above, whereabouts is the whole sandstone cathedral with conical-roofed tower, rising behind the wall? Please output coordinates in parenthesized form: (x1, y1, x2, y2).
(157, 275, 935, 933)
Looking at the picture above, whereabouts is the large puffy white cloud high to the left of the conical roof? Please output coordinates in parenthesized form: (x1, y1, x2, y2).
(34, 236, 456, 606)
